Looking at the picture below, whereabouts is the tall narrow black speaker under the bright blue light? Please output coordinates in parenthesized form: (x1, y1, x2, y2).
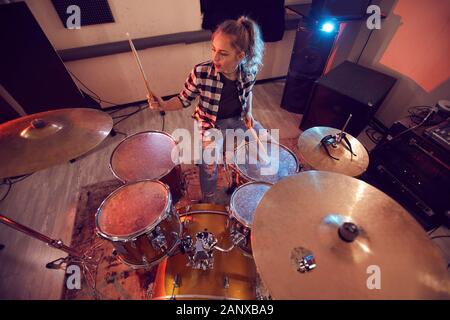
(281, 22, 336, 113)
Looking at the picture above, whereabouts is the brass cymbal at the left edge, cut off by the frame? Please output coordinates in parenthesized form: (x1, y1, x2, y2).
(0, 108, 113, 178)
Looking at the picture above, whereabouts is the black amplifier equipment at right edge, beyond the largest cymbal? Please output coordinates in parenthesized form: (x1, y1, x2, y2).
(364, 117, 450, 230)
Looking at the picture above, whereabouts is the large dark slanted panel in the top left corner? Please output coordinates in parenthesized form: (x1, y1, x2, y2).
(0, 2, 85, 114)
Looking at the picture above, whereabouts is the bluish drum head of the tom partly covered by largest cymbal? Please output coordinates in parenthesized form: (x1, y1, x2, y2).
(230, 182, 272, 228)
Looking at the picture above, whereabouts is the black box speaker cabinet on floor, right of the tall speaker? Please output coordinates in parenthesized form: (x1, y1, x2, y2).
(300, 61, 396, 137)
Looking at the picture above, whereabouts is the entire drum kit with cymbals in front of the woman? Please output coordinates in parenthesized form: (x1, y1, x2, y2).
(0, 109, 450, 299)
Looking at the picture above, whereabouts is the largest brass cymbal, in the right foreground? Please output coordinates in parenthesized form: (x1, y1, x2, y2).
(251, 171, 450, 299)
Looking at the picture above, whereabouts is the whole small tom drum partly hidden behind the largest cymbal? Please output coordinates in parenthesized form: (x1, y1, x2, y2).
(230, 182, 272, 255)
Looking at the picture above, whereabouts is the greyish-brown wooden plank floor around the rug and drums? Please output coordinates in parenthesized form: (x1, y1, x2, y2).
(0, 82, 450, 299)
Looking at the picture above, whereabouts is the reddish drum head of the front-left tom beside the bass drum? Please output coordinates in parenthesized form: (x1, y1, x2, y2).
(96, 181, 171, 241)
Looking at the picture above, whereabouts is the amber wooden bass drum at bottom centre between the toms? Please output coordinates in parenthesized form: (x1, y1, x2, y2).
(152, 204, 256, 300)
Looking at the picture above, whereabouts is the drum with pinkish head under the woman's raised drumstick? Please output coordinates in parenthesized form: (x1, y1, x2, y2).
(110, 131, 183, 202)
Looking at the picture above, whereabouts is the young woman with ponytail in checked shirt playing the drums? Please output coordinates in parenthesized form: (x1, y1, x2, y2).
(149, 17, 264, 202)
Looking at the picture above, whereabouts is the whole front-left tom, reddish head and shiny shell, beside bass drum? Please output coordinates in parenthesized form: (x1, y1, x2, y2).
(95, 180, 182, 268)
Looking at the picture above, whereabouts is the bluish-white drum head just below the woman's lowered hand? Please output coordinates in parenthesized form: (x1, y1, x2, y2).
(234, 141, 299, 184)
